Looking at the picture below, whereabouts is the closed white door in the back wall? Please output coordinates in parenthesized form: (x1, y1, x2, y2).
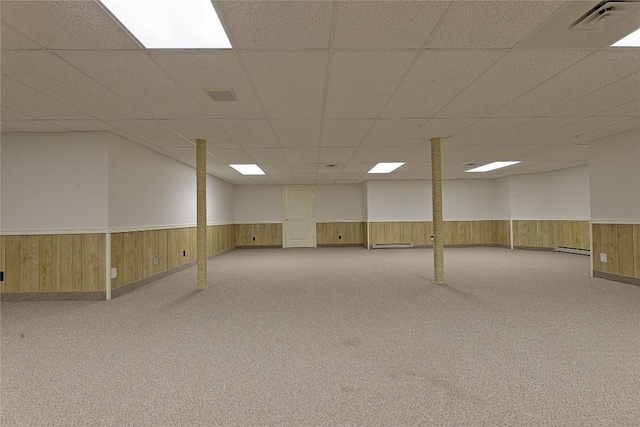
(282, 185, 316, 248)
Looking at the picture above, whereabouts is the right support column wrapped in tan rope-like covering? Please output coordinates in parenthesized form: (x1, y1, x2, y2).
(431, 137, 444, 285)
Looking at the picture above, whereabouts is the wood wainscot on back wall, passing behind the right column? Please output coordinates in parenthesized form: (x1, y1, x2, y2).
(369, 220, 509, 246)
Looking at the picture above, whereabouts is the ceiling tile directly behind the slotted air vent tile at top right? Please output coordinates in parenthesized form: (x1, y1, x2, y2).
(437, 50, 587, 117)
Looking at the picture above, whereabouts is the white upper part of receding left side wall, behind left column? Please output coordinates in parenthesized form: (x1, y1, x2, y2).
(109, 135, 235, 229)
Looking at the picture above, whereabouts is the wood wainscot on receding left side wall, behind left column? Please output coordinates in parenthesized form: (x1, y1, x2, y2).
(111, 225, 235, 296)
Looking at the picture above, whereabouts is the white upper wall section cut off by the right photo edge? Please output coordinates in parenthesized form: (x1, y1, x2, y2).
(589, 130, 640, 221)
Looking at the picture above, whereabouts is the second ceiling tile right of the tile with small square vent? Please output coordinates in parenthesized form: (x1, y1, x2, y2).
(325, 51, 416, 118)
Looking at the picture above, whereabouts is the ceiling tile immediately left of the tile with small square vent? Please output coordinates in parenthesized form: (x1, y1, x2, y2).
(55, 51, 208, 119)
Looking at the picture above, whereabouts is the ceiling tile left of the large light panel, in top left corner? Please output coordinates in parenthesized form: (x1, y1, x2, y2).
(2, 1, 141, 49)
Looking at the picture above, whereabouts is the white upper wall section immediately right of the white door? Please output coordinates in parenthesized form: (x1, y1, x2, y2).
(316, 184, 365, 222)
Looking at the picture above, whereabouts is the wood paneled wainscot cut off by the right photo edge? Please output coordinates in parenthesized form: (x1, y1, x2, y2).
(591, 224, 640, 286)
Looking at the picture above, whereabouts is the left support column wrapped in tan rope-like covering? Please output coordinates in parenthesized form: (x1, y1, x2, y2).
(196, 139, 207, 290)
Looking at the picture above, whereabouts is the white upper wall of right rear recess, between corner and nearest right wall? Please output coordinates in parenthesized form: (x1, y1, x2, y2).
(498, 166, 591, 220)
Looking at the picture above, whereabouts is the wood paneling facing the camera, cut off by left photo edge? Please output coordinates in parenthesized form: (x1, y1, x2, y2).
(0, 234, 106, 293)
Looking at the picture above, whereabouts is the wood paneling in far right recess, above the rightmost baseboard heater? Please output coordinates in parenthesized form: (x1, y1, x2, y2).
(513, 220, 589, 249)
